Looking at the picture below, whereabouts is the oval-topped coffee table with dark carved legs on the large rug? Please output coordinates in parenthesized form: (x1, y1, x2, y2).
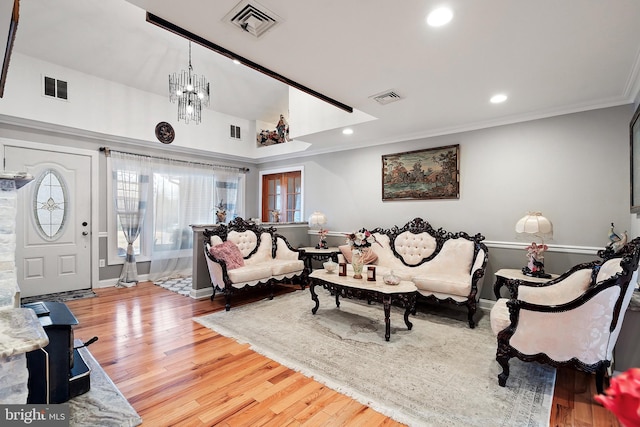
(309, 270, 418, 341)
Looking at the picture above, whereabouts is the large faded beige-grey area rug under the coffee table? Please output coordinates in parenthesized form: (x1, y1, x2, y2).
(194, 290, 555, 427)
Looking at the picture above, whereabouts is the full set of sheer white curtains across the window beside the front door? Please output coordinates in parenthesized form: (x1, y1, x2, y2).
(111, 151, 244, 283)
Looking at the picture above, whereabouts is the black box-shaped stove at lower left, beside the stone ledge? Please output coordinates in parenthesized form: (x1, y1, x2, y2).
(23, 302, 78, 404)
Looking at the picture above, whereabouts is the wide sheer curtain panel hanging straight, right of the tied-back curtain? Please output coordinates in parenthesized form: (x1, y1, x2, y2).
(149, 159, 215, 281)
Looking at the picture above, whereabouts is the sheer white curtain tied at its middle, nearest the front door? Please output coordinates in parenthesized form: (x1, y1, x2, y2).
(111, 152, 151, 287)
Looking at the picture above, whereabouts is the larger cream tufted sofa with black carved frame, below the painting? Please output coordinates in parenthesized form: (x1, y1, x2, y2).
(342, 218, 488, 328)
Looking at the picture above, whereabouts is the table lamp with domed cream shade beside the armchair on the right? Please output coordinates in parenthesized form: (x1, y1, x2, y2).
(516, 212, 553, 279)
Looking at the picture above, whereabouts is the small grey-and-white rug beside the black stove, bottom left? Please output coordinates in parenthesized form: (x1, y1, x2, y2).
(69, 340, 142, 427)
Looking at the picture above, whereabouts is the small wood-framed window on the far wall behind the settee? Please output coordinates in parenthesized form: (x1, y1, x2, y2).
(260, 168, 304, 222)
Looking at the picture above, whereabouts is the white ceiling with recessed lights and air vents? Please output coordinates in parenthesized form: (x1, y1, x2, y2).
(14, 0, 640, 152)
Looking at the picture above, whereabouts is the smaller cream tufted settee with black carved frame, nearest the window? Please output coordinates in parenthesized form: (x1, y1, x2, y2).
(203, 218, 308, 311)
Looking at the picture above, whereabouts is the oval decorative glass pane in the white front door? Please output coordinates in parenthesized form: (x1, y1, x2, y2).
(33, 169, 68, 240)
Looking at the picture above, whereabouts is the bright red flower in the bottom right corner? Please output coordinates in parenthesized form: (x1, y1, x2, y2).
(593, 368, 640, 426)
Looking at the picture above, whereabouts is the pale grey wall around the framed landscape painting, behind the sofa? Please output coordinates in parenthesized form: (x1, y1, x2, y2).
(260, 105, 634, 247)
